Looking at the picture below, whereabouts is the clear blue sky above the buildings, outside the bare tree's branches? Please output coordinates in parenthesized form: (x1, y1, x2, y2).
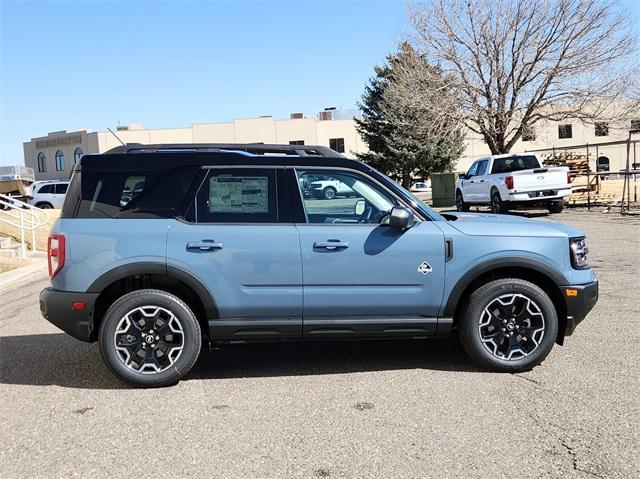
(0, 0, 640, 165)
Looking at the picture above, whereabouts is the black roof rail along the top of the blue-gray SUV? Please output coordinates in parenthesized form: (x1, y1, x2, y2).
(105, 143, 344, 158)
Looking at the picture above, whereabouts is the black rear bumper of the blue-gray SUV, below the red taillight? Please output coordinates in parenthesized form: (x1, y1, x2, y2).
(40, 288, 98, 342)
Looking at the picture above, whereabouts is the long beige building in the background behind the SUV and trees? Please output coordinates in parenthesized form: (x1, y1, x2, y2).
(24, 109, 640, 179)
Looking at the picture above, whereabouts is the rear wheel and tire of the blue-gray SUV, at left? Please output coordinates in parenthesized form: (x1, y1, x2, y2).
(98, 289, 202, 388)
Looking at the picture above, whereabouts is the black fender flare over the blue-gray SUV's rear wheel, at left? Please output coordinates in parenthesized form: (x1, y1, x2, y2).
(87, 261, 218, 318)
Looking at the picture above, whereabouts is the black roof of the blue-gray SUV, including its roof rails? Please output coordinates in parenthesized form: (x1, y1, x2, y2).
(76, 143, 371, 171)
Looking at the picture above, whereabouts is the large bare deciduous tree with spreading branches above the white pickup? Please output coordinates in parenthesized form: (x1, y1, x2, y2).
(409, 0, 638, 154)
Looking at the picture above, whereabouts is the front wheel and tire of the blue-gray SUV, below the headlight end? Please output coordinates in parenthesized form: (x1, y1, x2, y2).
(459, 278, 558, 373)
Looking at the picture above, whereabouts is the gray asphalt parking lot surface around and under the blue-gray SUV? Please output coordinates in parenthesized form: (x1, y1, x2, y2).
(0, 211, 640, 478)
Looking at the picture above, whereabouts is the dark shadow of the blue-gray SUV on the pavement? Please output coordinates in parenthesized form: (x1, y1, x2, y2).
(0, 334, 480, 389)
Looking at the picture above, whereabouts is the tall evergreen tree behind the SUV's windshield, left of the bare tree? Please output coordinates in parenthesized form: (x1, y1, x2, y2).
(356, 43, 464, 187)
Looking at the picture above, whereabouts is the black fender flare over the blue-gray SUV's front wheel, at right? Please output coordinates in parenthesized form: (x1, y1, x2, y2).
(440, 256, 568, 318)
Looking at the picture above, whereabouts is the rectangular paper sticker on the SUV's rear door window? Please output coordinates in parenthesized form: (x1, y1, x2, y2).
(209, 176, 269, 213)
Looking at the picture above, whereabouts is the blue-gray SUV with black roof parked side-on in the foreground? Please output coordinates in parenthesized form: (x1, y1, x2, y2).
(40, 144, 598, 387)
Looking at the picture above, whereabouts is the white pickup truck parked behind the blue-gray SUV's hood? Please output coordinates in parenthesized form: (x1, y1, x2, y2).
(456, 153, 572, 214)
